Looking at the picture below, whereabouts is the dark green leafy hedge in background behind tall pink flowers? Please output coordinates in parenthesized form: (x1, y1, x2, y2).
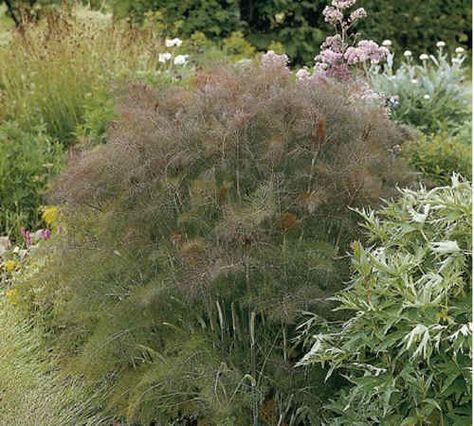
(111, 0, 472, 63)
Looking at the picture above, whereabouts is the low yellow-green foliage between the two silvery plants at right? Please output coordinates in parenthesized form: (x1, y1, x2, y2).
(403, 135, 472, 185)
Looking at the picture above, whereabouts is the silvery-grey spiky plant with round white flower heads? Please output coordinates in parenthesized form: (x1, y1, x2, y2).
(368, 42, 471, 136)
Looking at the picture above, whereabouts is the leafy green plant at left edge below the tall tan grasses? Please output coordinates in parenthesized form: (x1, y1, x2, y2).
(0, 122, 63, 238)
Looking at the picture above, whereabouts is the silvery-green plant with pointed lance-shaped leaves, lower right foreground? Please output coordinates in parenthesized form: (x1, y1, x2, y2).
(301, 175, 472, 425)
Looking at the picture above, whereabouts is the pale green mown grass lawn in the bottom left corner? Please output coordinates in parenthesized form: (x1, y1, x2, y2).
(0, 300, 110, 426)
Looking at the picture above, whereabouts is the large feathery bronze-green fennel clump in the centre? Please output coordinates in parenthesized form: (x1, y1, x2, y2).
(16, 61, 410, 425)
